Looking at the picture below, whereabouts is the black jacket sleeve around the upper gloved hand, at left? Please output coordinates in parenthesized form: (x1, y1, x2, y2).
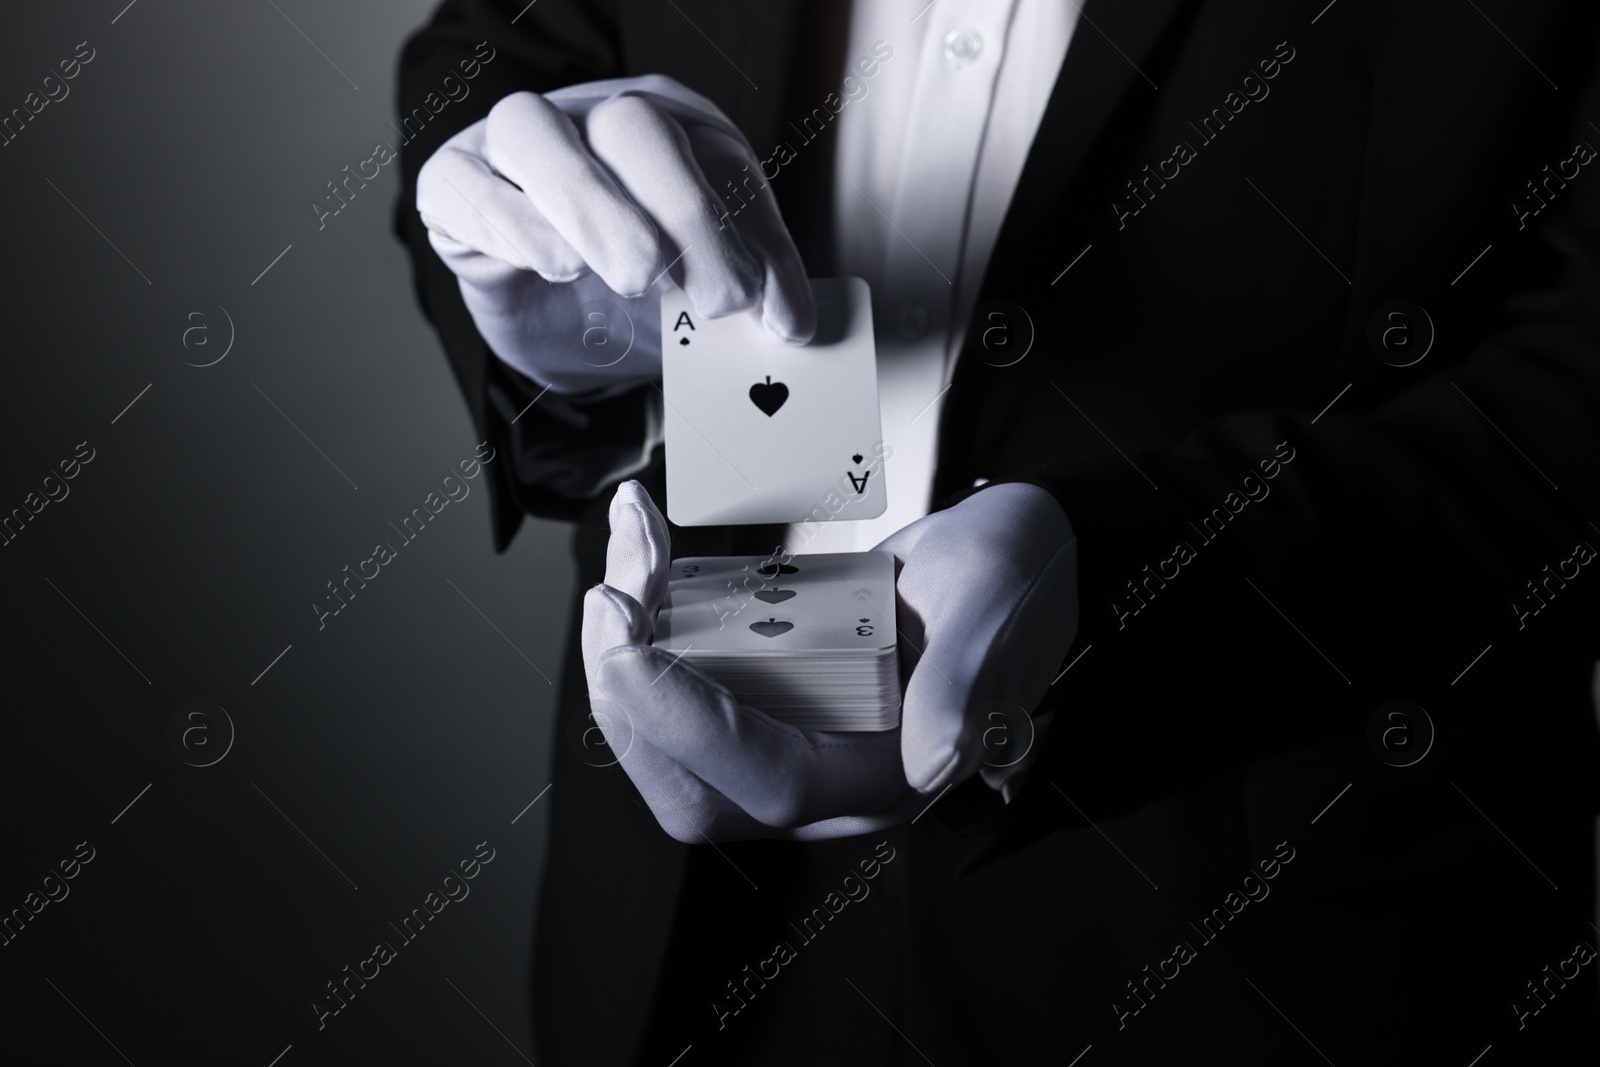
(395, 0, 659, 549)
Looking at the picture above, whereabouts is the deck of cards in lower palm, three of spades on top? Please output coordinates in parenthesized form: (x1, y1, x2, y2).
(654, 552, 901, 731)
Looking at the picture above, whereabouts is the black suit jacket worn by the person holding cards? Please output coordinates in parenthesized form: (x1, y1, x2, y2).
(397, 0, 1600, 1064)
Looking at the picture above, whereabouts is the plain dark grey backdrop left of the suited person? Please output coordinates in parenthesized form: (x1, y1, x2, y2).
(0, 0, 574, 1067)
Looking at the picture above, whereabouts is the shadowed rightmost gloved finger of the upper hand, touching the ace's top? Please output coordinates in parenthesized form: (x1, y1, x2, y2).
(688, 126, 816, 344)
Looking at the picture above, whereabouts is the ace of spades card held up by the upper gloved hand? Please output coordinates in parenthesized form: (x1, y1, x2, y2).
(661, 278, 888, 526)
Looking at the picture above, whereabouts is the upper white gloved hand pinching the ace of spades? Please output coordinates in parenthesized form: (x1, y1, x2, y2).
(416, 75, 816, 394)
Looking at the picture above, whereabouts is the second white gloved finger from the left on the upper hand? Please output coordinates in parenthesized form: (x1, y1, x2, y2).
(485, 93, 666, 296)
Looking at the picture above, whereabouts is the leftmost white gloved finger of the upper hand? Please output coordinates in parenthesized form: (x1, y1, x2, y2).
(416, 122, 589, 282)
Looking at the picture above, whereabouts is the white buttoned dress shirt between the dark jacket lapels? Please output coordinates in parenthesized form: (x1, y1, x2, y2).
(787, 0, 1078, 552)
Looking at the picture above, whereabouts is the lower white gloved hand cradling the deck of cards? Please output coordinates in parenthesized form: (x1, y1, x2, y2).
(582, 482, 1078, 843)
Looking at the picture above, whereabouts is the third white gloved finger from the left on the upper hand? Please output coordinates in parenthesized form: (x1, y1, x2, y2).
(584, 94, 762, 318)
